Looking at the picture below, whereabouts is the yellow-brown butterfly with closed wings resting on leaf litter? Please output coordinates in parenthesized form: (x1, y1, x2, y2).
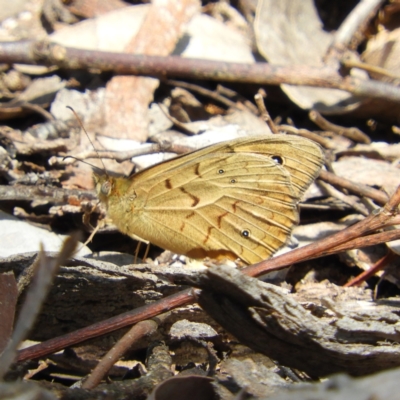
(94, 134, 324, 264)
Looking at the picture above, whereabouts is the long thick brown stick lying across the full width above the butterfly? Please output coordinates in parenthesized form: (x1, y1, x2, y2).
(0, 41, 400, 102)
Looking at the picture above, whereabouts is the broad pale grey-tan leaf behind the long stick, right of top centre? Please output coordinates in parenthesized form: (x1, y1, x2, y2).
(254, 0, 362, 112)
